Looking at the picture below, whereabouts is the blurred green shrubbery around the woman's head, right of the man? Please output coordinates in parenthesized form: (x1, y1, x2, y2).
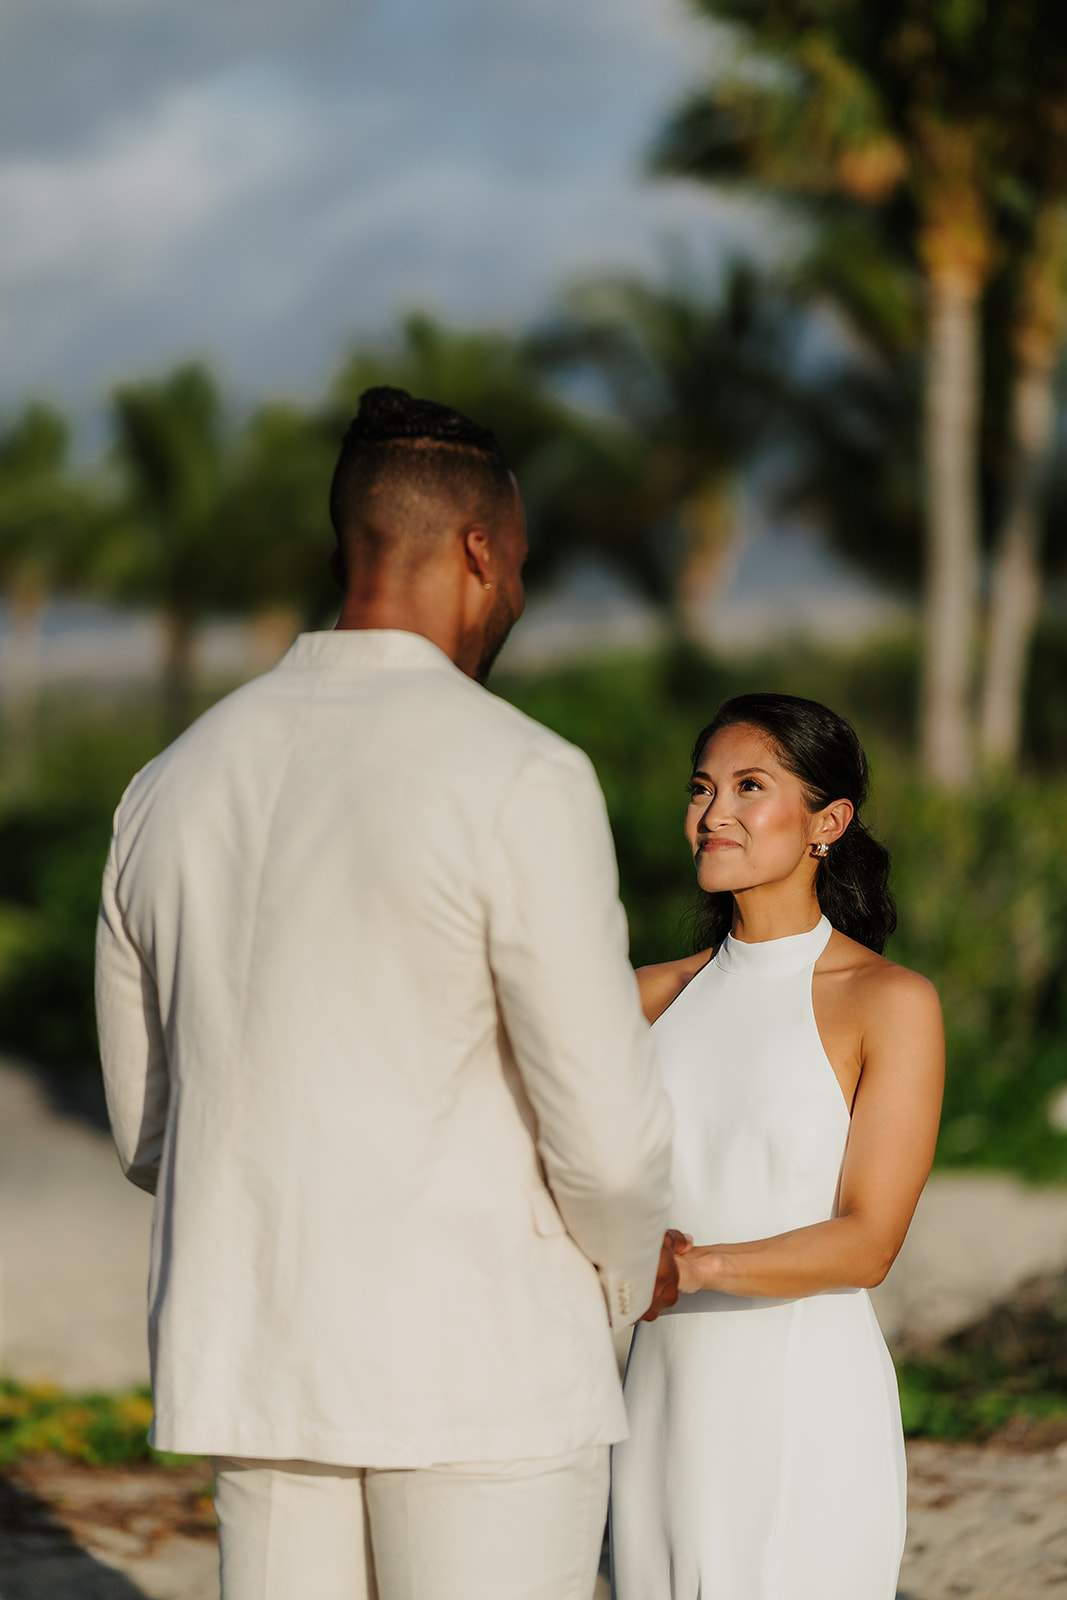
(507, 646, 1067, 1182)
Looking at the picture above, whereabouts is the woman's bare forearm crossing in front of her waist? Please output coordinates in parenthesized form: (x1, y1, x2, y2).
(678, 1216, 899, 1299)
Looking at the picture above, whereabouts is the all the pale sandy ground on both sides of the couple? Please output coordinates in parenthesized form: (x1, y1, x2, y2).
(0, 1062, 1067, 1600)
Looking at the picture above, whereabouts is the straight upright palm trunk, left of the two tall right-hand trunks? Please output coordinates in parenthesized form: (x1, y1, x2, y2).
(920, 272, 981, 789)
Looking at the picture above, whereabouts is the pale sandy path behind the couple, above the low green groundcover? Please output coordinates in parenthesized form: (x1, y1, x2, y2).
(0, 1061, 1067, 1388)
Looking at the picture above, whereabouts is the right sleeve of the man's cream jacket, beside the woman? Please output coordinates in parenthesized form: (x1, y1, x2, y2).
(488, 744, 672, 1328)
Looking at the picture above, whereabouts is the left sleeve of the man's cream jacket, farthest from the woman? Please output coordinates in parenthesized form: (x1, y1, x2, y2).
(96, 838, 170, 1194)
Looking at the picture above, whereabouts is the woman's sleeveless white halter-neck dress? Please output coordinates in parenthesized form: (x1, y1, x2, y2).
(611, 917, 905, 1600)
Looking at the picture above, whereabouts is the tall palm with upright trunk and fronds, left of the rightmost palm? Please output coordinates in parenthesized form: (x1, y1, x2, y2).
(657, 0, 1067, 787)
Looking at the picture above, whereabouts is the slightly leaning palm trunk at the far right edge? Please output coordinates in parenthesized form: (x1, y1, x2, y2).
(981, 208, 1067, 770)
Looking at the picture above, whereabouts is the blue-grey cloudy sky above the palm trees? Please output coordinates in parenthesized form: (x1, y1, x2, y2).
(0, 0, 767, 425)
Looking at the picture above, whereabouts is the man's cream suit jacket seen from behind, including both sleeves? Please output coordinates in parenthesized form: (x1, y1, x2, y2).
(98, 630, 670, 1466)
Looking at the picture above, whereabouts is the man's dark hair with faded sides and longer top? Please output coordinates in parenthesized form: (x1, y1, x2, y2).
(330, 387, 515, 566)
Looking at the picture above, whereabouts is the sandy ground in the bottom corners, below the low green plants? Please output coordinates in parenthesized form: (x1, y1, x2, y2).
(0, 1440, 1067, 1600)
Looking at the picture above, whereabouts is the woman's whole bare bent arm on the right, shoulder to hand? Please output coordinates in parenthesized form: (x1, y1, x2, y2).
(678, 962, 944, 1298)
